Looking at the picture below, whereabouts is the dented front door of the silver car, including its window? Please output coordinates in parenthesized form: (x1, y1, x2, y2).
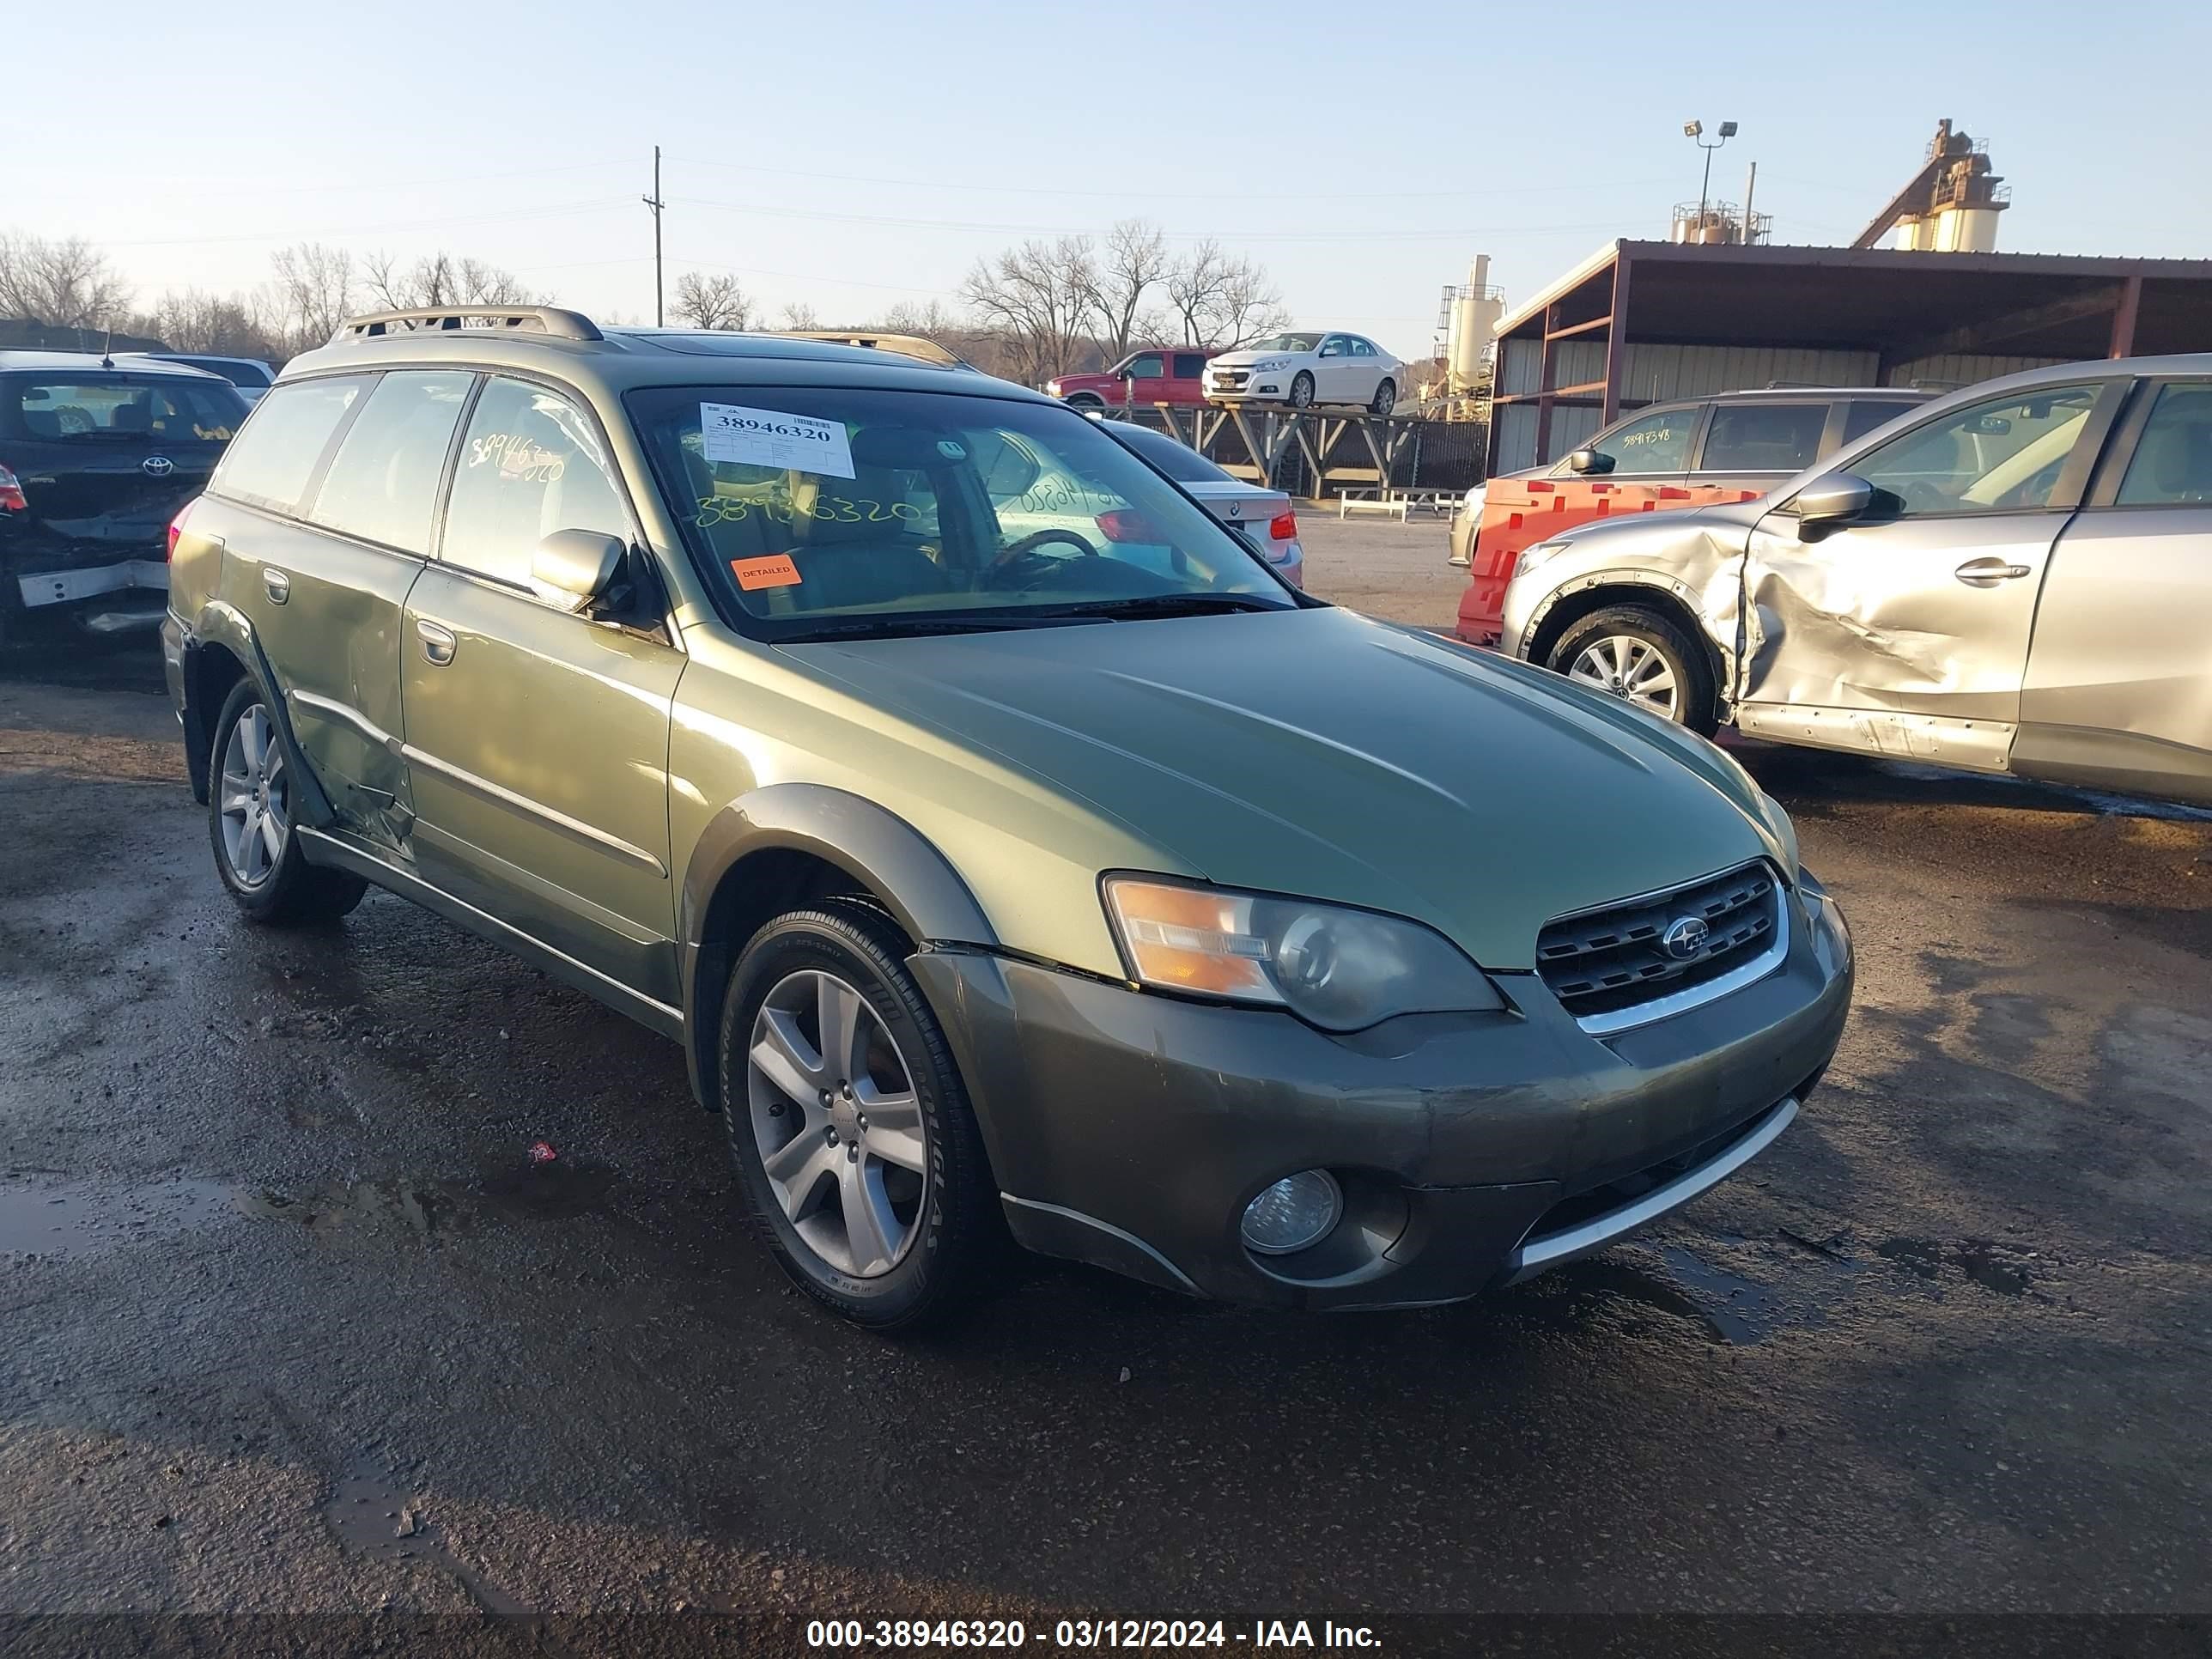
(1736, 383, 2124, 772)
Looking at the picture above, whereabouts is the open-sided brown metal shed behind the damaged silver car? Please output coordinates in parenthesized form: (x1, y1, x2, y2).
(1489, 241, 2212, 476)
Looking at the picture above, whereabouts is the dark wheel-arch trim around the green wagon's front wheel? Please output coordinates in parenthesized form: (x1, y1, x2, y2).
(677, 783, 998, 1106)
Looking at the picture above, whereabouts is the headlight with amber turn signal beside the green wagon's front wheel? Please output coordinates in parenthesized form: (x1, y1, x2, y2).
(1106, 876, 1504, 1030)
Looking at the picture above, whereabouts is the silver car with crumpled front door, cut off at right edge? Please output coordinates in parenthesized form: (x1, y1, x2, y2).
(1502, 354, 2212, 801)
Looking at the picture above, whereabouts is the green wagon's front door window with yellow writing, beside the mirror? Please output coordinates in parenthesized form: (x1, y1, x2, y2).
(438, 376, 632, 586)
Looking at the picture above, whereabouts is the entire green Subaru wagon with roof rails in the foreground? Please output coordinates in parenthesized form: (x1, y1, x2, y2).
(164, 310, 1851, 1328)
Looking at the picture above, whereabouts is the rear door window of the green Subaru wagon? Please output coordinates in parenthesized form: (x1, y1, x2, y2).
(307, 372, 476, 556)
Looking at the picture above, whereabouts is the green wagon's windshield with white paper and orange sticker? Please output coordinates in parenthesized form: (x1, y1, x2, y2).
(629, 387, 1298, 639)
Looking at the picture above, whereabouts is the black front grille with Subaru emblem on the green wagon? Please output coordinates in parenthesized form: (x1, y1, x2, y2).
(1535, 863, 1783, 1022)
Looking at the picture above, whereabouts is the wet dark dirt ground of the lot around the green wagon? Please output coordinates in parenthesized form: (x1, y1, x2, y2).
(0, 579, 2212, 1655)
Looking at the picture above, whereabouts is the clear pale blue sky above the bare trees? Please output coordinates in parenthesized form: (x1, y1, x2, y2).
(17, 0, 2212, 356)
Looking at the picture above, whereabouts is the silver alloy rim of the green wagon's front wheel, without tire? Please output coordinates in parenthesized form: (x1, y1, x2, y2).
(745, 969, 929, 1279)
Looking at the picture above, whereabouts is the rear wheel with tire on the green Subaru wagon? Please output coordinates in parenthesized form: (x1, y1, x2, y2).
(208, 679, 368, 927)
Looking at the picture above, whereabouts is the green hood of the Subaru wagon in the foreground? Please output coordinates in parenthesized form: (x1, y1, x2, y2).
(785, 608, 1781, 971)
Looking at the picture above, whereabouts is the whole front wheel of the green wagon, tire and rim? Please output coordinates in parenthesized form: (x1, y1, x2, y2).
(719, 898, 998, 1332)
